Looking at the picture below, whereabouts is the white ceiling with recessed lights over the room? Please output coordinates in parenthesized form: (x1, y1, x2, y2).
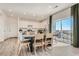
(0, 3, 74, 21)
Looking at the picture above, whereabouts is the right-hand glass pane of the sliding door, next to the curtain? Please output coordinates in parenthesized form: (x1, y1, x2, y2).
(62, 18, 72, 43)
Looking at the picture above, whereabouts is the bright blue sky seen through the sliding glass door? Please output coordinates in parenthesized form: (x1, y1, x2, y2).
(56, 17, 72, 30)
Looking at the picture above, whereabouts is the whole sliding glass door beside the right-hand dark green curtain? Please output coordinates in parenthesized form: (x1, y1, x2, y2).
(54, 17, 72, 44)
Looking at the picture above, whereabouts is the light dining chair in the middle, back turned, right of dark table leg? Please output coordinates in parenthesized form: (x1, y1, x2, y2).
(34, 34, 44, 54)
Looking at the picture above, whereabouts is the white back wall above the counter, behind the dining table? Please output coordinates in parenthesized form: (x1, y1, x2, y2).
(19, 17, 49, 30)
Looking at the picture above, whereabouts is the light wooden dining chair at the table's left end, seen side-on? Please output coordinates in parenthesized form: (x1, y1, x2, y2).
(17, 39, 30, 55)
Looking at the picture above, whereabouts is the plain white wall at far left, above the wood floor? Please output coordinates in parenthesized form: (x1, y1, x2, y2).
(0, 11, 18, 41)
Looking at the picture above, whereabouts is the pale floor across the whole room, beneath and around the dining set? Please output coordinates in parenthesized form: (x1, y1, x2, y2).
(0, 38, 79, 56)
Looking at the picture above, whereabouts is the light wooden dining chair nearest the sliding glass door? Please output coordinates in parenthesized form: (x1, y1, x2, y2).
(45, 33, 53, 49)
